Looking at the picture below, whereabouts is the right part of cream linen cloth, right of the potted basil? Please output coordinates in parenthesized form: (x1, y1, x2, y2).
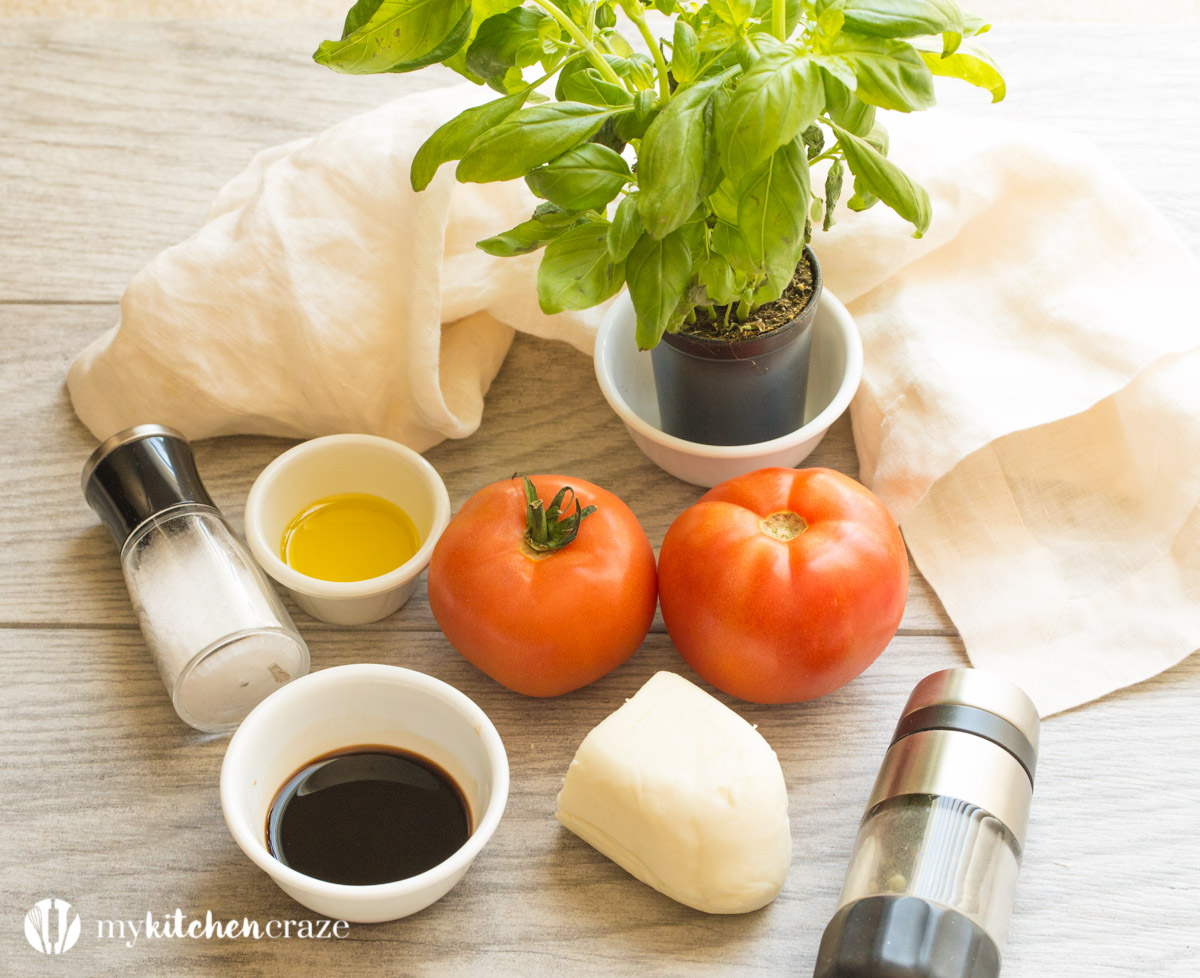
(818, 115, 1200, 714)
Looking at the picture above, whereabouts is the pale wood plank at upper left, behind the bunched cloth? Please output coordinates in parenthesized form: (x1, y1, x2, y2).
(0, 19, 457, 299)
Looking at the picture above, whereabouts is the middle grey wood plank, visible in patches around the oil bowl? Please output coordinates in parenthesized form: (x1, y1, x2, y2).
(0, 305, 953, 634)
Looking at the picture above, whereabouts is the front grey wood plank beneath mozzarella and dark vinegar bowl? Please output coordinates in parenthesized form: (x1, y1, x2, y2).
(0, 630, 1200, 978)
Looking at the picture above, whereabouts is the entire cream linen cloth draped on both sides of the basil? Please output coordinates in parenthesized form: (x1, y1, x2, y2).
(68, 86, 1200, 713)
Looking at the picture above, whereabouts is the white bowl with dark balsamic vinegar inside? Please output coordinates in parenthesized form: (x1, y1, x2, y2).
(221, 664, 509, 923)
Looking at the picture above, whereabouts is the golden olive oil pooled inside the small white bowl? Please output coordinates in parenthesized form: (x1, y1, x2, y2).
(282, 492, 421, 581)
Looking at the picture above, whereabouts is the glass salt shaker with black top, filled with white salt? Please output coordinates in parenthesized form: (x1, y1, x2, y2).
(83, 425, 308, 732)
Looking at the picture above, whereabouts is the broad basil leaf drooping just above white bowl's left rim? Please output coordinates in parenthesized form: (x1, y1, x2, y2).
(538, 221, 625, 313)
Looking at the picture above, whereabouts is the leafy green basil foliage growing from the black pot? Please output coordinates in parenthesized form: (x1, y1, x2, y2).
(313, 0, 1004, 349)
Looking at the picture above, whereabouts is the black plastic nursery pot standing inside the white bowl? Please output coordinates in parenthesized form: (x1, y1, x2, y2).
(650, 248, 821, 445)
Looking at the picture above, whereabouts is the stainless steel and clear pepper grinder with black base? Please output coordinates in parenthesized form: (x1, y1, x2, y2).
(814, 668, 1039, 978)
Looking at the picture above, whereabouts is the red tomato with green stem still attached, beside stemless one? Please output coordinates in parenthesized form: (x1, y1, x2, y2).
(430, 475, 658, 696)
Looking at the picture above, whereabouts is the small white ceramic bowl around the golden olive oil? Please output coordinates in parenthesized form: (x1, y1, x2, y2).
(246, 434, 450, 625)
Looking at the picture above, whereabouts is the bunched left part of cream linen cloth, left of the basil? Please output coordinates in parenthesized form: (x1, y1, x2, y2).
(67, 85, 602, 451)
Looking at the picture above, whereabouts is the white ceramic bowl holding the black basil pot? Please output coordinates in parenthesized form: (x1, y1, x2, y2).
(595, 289, 863, 486)
